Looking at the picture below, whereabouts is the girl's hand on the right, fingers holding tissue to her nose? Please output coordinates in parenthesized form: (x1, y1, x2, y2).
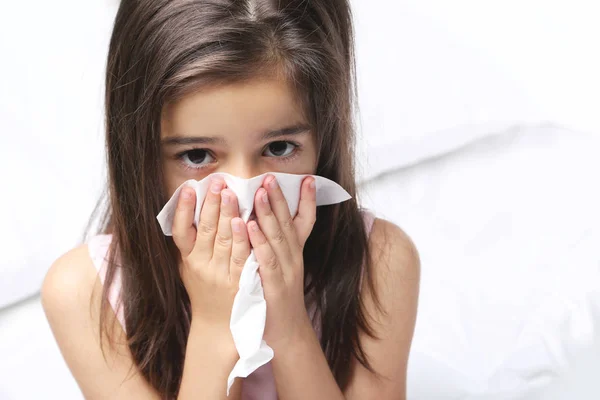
(248, 175, 317, 349)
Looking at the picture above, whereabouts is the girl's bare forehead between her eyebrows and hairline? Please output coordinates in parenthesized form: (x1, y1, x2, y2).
(161, 79, 307, 137)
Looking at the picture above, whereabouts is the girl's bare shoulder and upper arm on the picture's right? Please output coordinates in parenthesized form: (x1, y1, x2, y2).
(345, 219, 421, 400)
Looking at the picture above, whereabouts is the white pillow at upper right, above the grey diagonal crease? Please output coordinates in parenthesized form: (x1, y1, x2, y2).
(352, 0, 600, 179)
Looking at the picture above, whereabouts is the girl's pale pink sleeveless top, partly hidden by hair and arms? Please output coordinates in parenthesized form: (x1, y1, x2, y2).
(88, 209, 375, 400)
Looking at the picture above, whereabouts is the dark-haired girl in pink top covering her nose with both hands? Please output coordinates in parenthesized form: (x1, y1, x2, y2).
(42, 0, 420, 400)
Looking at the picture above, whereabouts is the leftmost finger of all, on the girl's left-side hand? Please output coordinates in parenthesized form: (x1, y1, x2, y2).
(172, 186, 196, 258)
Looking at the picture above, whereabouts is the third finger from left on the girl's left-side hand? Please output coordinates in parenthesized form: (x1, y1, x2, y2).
(212, 189, 238, 273)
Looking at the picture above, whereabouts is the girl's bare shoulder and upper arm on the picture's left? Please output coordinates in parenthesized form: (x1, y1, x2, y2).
(42, 245, 156, 399)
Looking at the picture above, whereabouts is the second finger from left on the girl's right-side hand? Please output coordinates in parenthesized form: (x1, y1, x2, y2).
(254, 188, 294, 274)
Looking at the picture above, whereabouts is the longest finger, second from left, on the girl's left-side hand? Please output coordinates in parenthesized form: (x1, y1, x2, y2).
(193, 179, 224, 260)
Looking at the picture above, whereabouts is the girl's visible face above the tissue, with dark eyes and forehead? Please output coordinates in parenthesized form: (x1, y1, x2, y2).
(161, 80, 317, 196)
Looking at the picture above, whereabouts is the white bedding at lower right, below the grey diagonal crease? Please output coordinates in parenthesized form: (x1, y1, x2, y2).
(361, 126, 600, 400)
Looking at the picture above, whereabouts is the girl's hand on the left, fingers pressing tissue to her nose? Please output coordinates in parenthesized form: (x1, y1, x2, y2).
(172, 178, 250, 337)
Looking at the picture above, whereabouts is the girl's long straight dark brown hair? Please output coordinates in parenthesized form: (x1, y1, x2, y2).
(89, 0, 374, 398)
